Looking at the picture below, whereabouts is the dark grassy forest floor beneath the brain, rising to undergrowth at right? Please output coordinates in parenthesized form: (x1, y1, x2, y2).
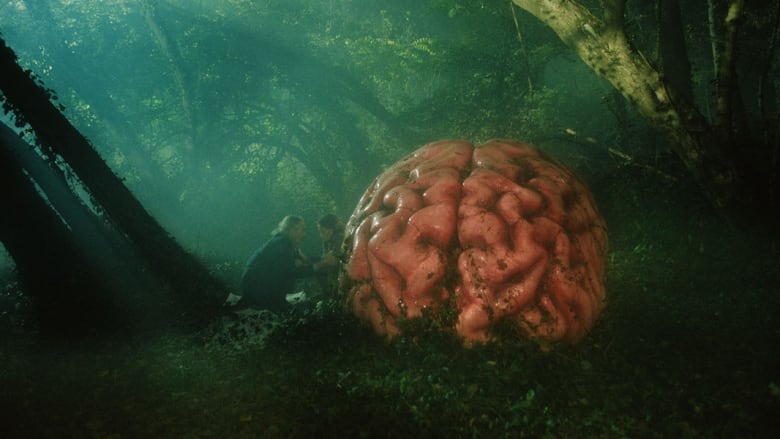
(0, 180, 780, 439)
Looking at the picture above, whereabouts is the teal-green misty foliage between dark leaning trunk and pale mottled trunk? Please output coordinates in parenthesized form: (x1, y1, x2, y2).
(0, 2, 616, 276)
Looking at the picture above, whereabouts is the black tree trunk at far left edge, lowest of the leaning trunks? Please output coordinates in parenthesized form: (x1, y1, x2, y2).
(0, 125, 118, 332)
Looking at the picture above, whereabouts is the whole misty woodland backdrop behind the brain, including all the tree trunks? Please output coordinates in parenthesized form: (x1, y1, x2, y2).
(0, 0, 780, 330)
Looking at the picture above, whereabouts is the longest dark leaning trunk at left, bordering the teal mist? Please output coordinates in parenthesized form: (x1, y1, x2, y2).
(0, 39, 226, 320)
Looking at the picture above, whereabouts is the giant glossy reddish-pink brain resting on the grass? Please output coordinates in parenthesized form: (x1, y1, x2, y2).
(341, 140, 607, 345)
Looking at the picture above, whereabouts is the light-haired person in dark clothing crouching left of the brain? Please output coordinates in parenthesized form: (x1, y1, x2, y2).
(237, 215, 338, 312)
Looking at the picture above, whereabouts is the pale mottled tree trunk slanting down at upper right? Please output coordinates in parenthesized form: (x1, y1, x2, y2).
(512, 0, 736, 207)
